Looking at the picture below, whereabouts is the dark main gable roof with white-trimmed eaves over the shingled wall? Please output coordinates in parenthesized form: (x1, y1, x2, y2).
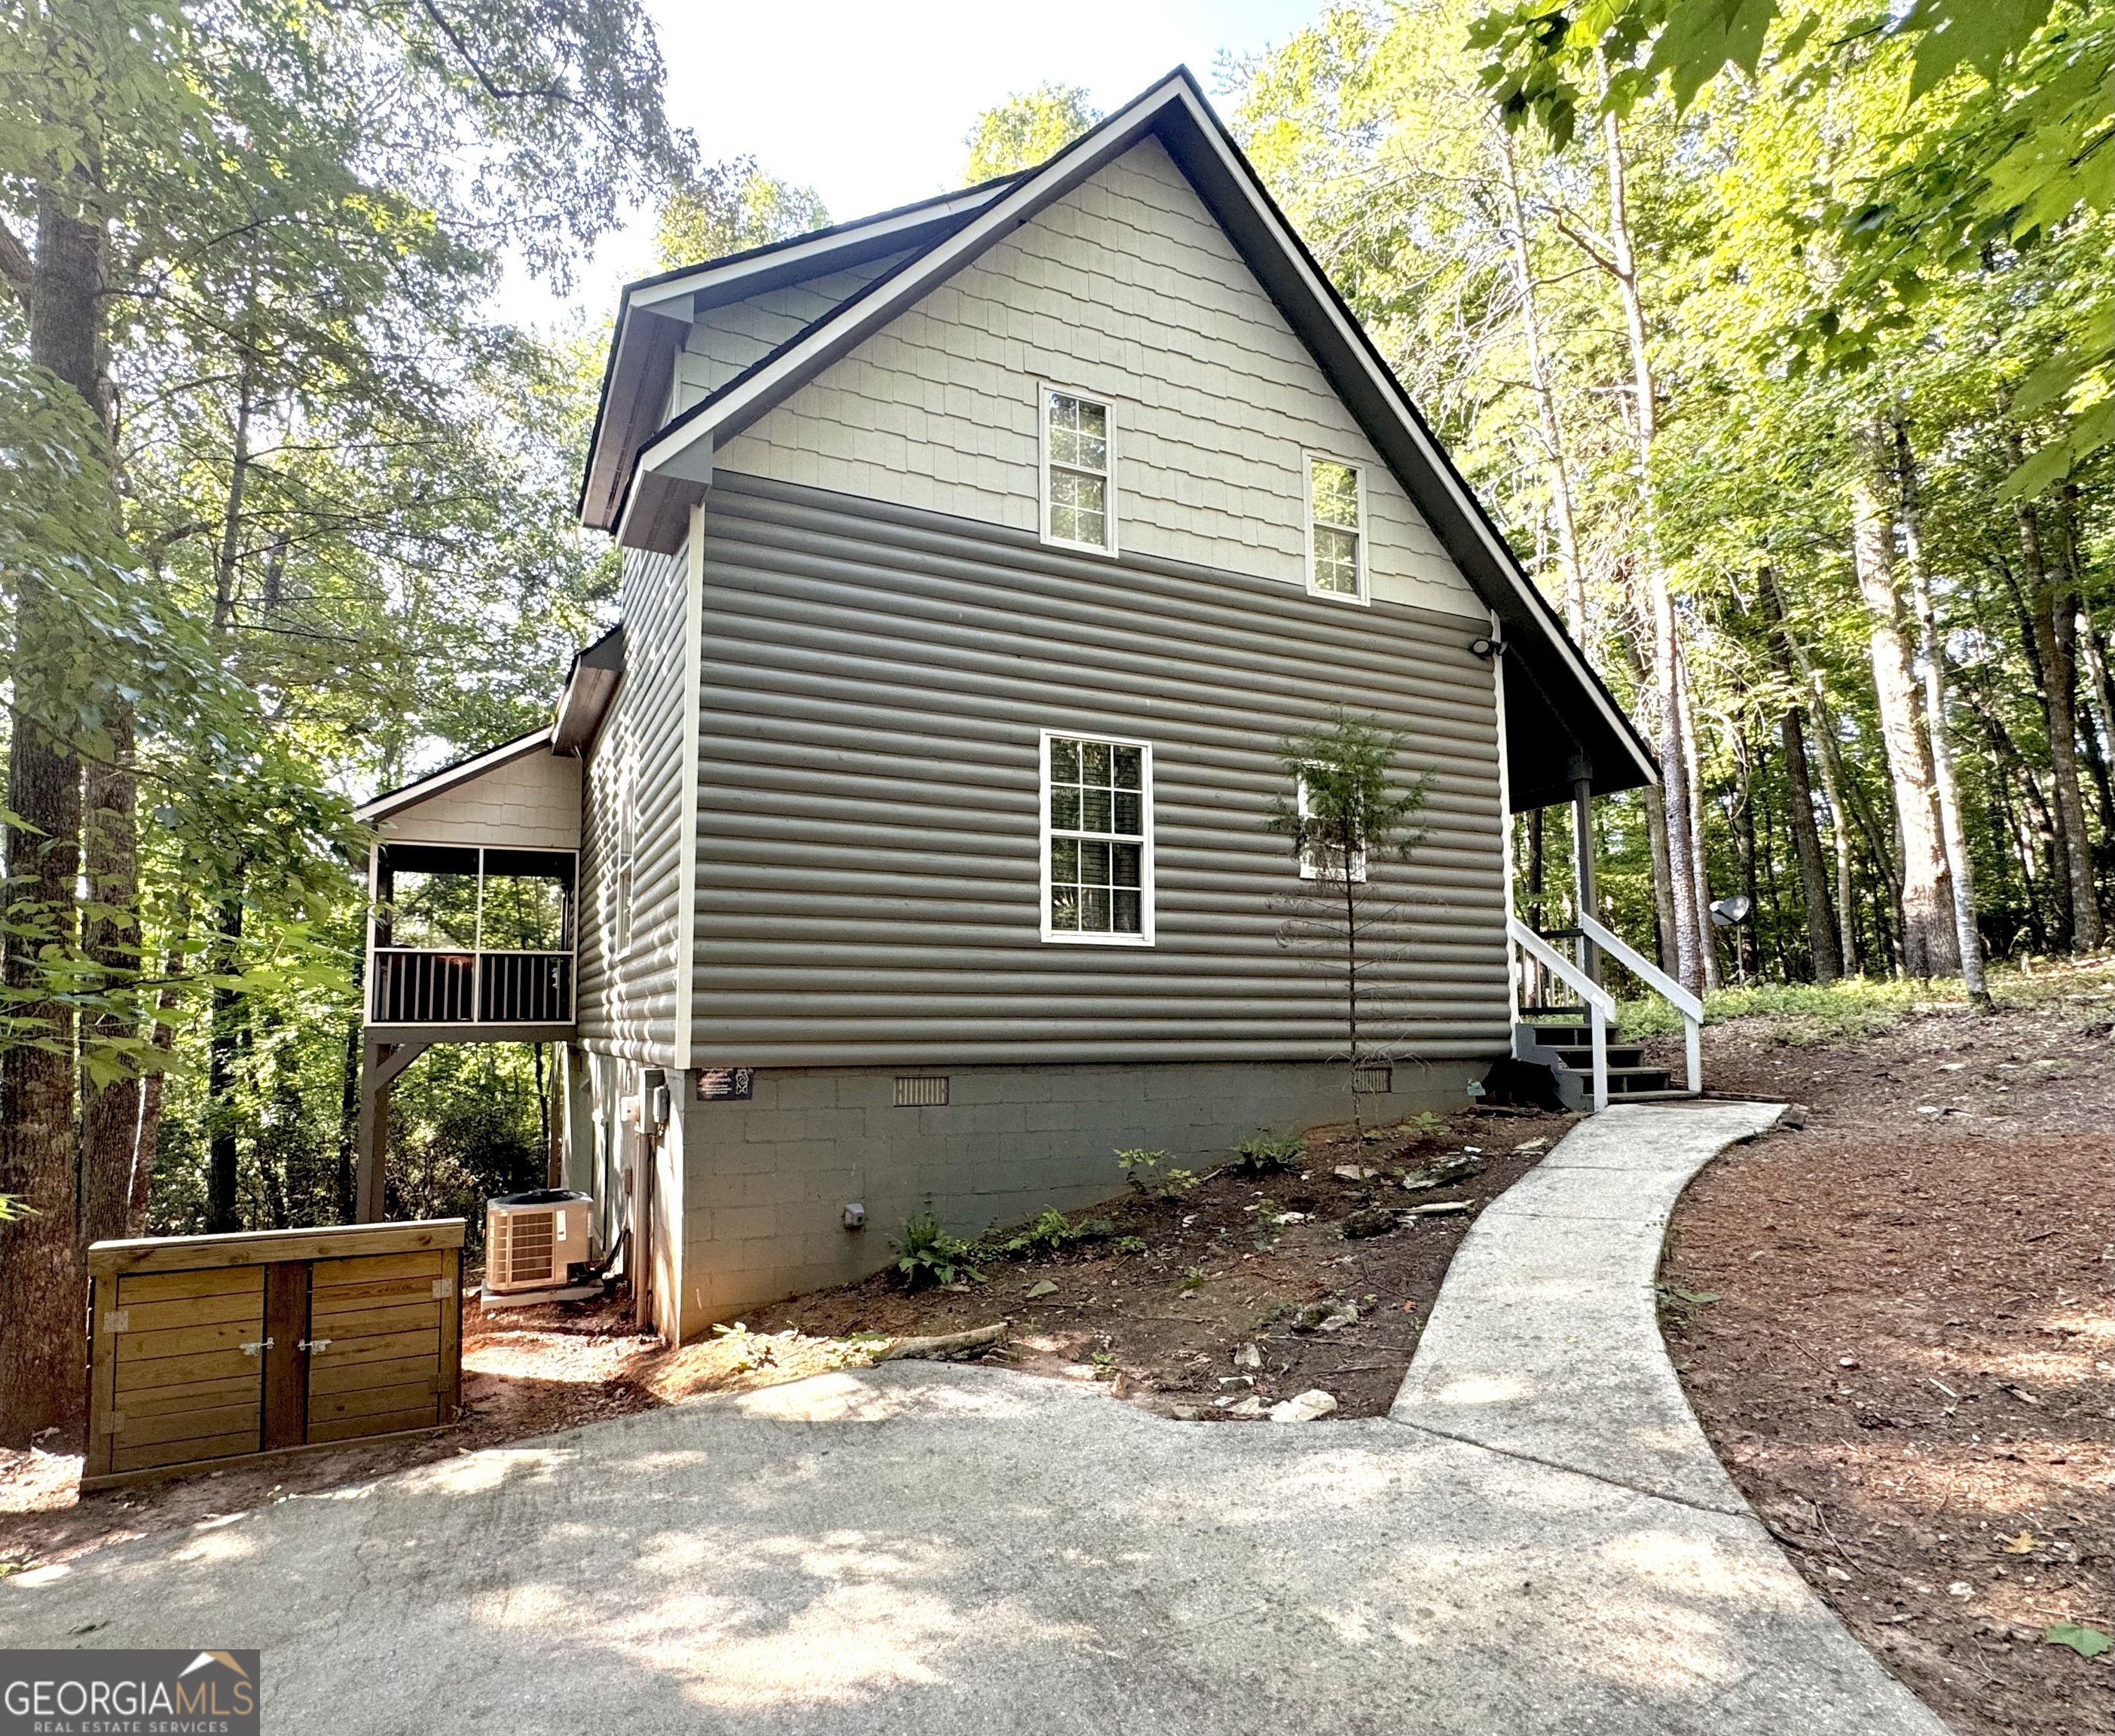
(588, 68, 1658, 810)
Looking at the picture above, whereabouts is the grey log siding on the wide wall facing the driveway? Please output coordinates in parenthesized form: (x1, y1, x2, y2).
(692, 475, 1508, 1065)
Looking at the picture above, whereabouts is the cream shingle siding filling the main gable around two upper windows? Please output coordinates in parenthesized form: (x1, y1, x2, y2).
(711, 139, 1481, 613)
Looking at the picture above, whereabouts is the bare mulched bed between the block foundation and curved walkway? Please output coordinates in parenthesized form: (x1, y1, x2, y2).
(749, 1110, 1576, 1421)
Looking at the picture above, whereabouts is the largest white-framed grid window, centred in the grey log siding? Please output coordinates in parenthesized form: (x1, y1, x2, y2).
(1043, 732, 1153, 945)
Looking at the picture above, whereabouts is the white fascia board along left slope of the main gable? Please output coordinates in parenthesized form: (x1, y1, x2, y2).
(632, 76, 1189, 486)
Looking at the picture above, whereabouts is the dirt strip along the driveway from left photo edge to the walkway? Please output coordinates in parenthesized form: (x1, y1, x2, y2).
(0, 1108, 1573, 1573)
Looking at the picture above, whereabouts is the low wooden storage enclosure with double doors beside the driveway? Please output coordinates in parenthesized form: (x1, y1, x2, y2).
(81, 1218, 463, 1489)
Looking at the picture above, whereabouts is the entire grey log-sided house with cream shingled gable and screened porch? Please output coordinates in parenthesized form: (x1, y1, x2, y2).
(362, 70, 1654, 1337)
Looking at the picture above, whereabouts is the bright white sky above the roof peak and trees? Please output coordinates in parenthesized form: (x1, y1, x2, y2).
(499, 0, 1322, 326)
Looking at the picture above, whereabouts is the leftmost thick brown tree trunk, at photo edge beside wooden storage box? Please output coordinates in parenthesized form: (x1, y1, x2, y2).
(0, 186, 108, 1444)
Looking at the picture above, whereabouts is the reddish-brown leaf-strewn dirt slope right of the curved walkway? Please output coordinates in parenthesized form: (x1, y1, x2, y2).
(1662, 979, 2115, 1736)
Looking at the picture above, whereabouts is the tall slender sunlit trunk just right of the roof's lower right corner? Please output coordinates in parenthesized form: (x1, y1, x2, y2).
(1601, 110, 1704, 994)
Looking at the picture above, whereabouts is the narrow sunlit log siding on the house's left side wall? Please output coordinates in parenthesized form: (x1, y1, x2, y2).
(579, 550, 689, 1062)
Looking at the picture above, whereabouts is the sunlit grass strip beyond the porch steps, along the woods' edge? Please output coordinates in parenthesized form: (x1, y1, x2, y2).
(1618, 954, 2115, 1049)
